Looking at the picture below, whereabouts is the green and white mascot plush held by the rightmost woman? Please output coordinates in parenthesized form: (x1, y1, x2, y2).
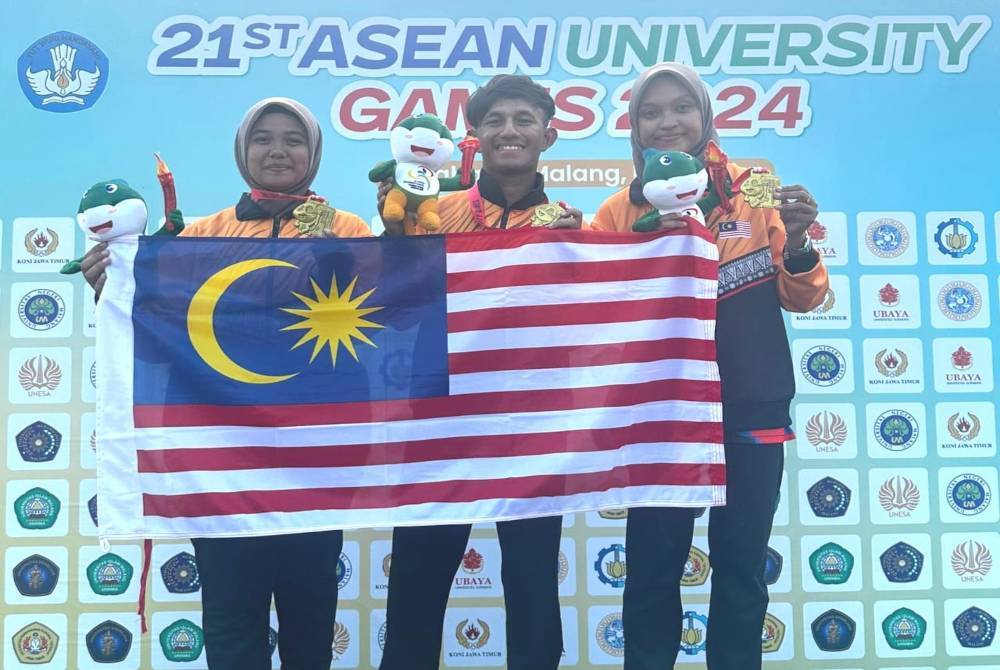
(632, 151, 708, 233)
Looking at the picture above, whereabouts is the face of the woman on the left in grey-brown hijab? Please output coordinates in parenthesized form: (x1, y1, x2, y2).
(247, 112, 309, 192)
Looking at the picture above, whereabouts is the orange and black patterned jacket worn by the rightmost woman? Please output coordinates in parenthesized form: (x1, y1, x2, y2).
(590, 163, 829, 443)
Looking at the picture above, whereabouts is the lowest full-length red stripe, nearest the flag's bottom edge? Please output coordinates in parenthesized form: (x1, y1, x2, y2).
(142, 463, 726, 519)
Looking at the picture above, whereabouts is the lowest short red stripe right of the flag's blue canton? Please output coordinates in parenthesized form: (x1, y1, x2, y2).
(448, 337, 715, 375)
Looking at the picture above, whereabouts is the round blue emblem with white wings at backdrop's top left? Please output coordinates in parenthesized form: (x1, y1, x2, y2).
(17, 31, 108, 112)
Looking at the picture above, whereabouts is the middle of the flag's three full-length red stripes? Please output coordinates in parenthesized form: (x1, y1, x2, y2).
(137, 421, 722, 473)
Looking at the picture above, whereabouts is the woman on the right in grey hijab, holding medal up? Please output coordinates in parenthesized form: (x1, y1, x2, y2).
(592, 63, 836, 670)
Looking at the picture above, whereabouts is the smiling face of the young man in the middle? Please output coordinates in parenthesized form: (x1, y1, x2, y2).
(475, 98, 556, 174)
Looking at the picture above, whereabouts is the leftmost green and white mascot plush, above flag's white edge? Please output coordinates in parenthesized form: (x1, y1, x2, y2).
(59, 179, 184, 275)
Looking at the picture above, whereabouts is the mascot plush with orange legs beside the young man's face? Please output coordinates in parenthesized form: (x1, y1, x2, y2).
(368, 114, 475, 230)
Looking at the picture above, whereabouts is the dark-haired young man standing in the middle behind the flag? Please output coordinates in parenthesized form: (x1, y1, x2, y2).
(379, 75, 582, 670)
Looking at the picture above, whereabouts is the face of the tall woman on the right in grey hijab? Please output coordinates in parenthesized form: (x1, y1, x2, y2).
(635, 76, 702, 152)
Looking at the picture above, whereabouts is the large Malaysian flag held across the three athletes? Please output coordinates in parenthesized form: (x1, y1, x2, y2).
(97, 229, 725, 539)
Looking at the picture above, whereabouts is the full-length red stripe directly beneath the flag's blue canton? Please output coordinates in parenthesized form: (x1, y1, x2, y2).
(133, 379, 721, 428)
